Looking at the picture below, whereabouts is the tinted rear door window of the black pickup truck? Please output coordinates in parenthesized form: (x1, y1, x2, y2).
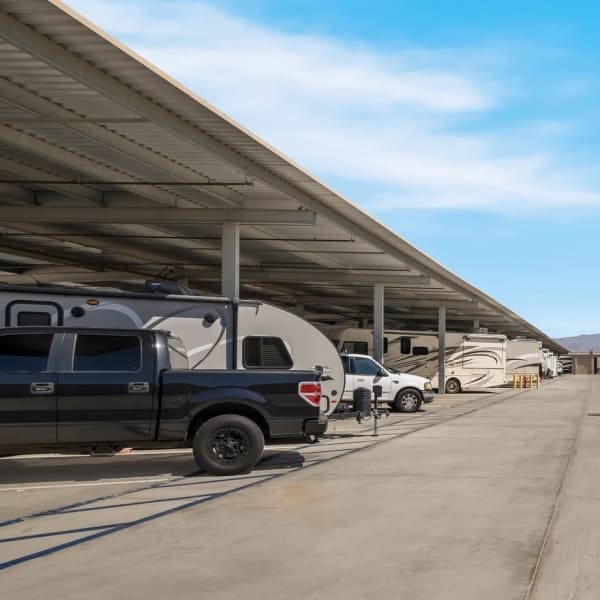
(73, 334, 142, 371)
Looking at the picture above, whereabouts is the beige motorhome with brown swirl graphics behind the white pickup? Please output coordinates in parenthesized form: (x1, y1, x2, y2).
(322, 327, 506, 394)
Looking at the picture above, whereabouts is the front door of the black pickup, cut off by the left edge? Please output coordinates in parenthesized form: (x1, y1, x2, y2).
(0, 332, 62, 446)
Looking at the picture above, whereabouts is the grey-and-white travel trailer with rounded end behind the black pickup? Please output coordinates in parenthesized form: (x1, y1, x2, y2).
(0, 286, 344, 414)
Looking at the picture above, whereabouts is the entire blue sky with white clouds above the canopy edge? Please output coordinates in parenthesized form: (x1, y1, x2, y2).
(68, 0, 600, 337)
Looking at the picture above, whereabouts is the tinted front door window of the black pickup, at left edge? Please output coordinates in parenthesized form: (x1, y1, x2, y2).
(0, 333, 53, 373)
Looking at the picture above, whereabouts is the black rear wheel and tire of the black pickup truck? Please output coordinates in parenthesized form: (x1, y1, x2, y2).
(193, 415, 265, 475)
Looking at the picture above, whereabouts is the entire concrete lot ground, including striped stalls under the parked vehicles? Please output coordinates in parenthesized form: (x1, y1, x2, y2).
(0, 376, 600, 600)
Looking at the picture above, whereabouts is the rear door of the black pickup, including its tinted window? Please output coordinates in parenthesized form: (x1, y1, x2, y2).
(57, 332, 156, 443)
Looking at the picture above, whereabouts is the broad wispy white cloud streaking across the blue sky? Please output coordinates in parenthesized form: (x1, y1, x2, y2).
(64, 0, 600, 212)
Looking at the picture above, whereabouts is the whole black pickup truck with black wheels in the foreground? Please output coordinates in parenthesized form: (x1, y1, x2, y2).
(0, 327, 327, 475)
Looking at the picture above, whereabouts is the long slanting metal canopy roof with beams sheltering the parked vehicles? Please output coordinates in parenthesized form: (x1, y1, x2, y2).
(0, 0, 566, 352)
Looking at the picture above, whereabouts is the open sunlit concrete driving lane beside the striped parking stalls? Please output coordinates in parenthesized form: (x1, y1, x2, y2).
(0, 376, 600, 600)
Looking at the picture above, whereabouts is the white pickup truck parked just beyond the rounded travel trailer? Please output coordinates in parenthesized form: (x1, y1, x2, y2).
(342, 354, 433, 412)
